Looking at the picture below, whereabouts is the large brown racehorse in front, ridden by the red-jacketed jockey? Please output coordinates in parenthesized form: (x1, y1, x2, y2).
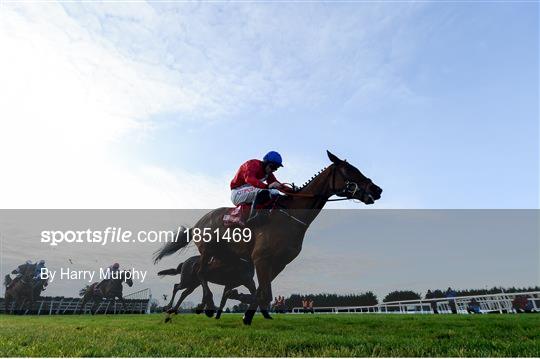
(155, 151, 382, 325)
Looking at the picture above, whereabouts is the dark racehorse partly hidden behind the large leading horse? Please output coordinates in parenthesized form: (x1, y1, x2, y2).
(158, 256, 256, 322)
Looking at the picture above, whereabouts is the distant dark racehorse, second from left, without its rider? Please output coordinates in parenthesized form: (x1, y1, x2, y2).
(79, 271, 133, 314)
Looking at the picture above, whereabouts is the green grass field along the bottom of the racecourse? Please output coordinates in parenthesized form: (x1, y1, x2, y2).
(0, 314, 540, 357)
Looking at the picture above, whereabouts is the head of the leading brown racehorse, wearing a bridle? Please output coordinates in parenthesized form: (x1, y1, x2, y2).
(326, 151, 382, 204)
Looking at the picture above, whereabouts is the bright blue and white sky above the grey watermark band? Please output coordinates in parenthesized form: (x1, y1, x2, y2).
(0, 1, 540, 306)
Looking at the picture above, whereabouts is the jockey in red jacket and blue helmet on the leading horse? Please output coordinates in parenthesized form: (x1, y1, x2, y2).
(231, 151, 283, 222)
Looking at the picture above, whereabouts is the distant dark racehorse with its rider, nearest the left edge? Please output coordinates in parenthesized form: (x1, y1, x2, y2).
(4, 265, 43, 313)
